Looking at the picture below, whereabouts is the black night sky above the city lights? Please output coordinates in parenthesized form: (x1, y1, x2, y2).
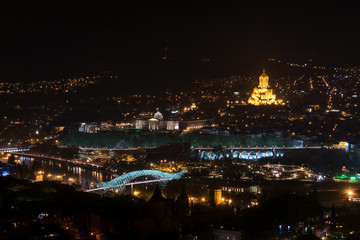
(0, 1, 360, 83)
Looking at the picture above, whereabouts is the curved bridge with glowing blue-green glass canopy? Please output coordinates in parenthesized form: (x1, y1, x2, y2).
(87, 170, 185, 192)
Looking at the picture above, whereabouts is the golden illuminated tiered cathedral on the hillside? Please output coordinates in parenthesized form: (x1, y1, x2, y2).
(248, 70, 283, 105)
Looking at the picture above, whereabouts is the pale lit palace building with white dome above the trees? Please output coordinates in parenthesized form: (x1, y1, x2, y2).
(135, 109, 179, 131)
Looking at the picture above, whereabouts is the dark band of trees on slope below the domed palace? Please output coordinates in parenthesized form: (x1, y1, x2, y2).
(61, 131, 306, 148)
